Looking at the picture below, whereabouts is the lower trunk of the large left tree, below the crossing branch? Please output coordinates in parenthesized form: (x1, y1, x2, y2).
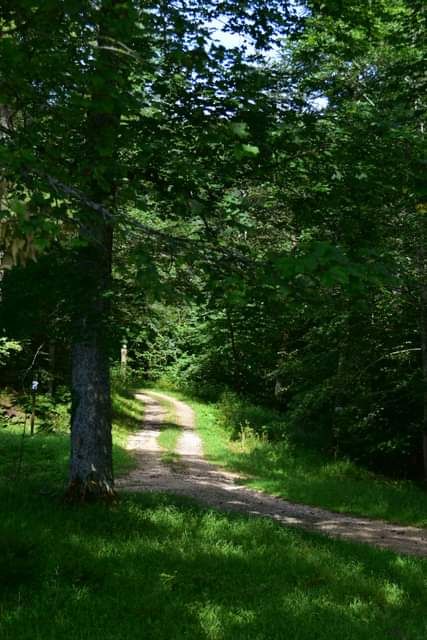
(67, 221, 114, 500)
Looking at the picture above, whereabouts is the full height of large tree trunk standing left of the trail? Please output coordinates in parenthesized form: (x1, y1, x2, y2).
(67, 0, 127, 500)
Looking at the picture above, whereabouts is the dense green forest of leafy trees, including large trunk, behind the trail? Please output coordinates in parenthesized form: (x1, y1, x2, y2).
(0, 0, 427, 494)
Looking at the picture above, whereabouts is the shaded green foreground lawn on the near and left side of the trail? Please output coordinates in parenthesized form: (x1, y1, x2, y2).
(0, 388, 427, 640)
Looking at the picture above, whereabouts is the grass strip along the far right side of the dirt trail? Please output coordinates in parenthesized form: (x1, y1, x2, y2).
(151, 390, 427, 527)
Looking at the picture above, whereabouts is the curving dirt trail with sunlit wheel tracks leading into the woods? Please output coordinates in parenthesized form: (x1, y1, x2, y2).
(117, 391, 427, 556)
